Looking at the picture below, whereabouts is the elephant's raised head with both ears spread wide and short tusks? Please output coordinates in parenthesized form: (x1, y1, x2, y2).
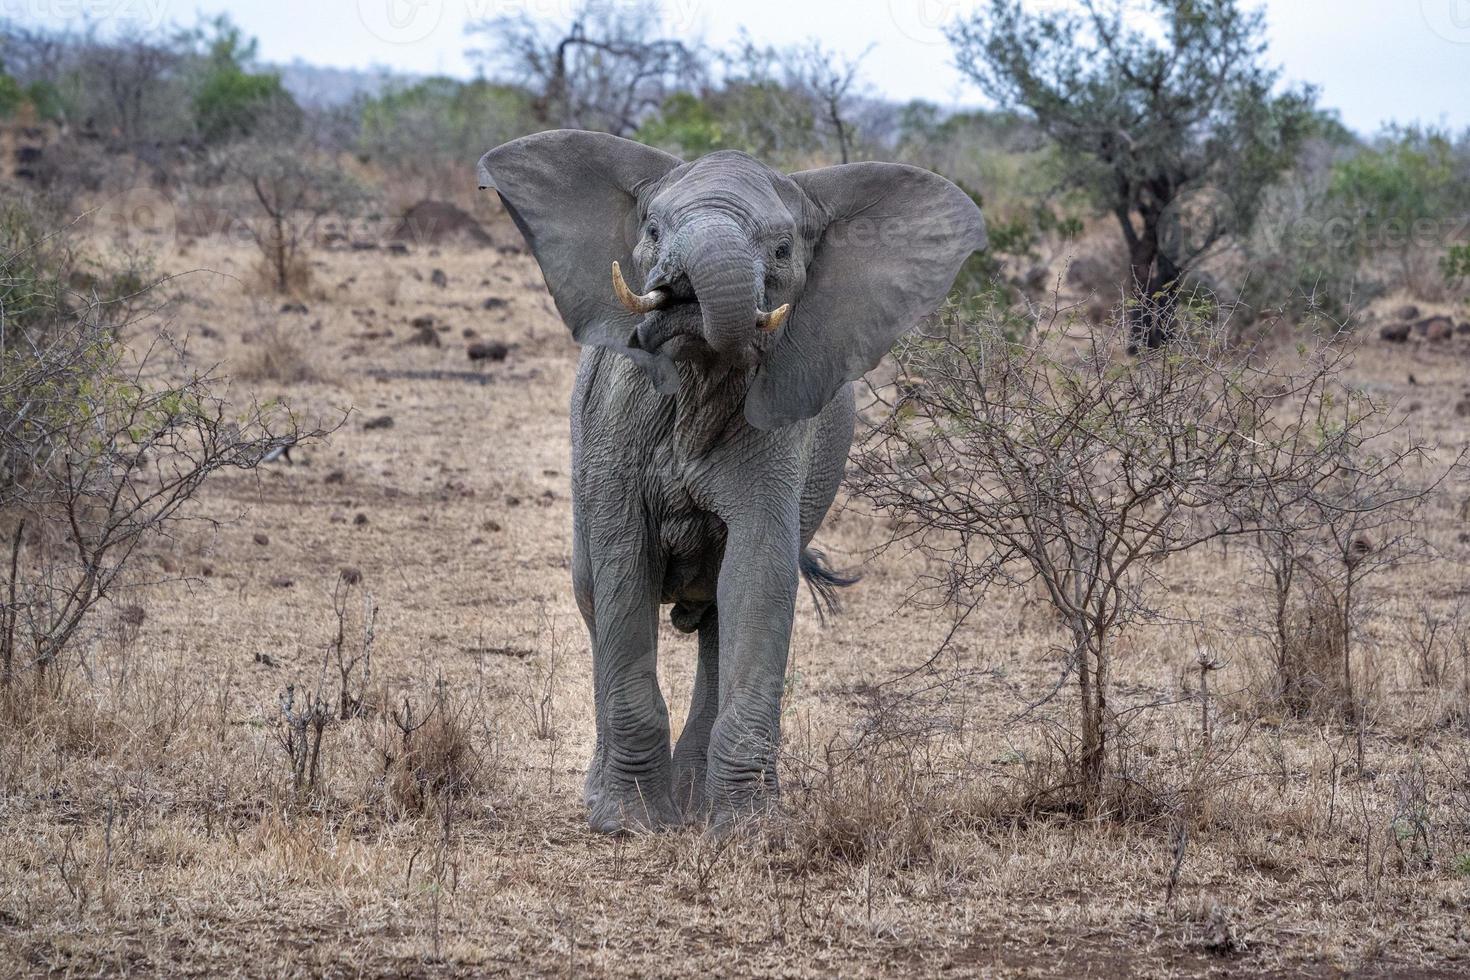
(479, 131, 985, 429)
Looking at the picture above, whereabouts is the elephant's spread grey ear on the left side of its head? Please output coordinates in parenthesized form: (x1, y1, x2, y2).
(479, 129, 682, 347)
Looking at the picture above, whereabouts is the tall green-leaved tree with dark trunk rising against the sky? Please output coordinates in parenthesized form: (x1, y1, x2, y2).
(950, 0, 1316, 347)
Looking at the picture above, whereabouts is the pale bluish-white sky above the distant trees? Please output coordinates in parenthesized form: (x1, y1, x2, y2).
(11, 0, 1470, 134)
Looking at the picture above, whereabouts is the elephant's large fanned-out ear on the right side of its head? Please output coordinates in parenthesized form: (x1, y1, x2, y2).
(745, 163, 986, 429)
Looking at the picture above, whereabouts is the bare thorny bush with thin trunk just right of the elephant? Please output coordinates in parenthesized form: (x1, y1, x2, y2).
(853, 304, 1434, 811)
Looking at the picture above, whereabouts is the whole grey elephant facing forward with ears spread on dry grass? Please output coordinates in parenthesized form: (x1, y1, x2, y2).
(478, 131, 986, 833)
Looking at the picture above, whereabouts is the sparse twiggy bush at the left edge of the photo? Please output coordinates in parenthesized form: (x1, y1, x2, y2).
(0, 195, 320, 685)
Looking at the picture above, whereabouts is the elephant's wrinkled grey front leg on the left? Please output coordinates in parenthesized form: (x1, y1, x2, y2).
(585, 522, 675, 833)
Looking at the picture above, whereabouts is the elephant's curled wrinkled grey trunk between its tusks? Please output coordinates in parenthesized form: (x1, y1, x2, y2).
(684, 216, 766, 356)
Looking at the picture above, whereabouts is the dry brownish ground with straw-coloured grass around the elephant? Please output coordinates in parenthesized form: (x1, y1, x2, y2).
(0, 226, 1470, 977)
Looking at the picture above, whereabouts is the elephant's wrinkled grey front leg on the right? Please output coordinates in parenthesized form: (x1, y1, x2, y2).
(706, 511, 801, 823)
